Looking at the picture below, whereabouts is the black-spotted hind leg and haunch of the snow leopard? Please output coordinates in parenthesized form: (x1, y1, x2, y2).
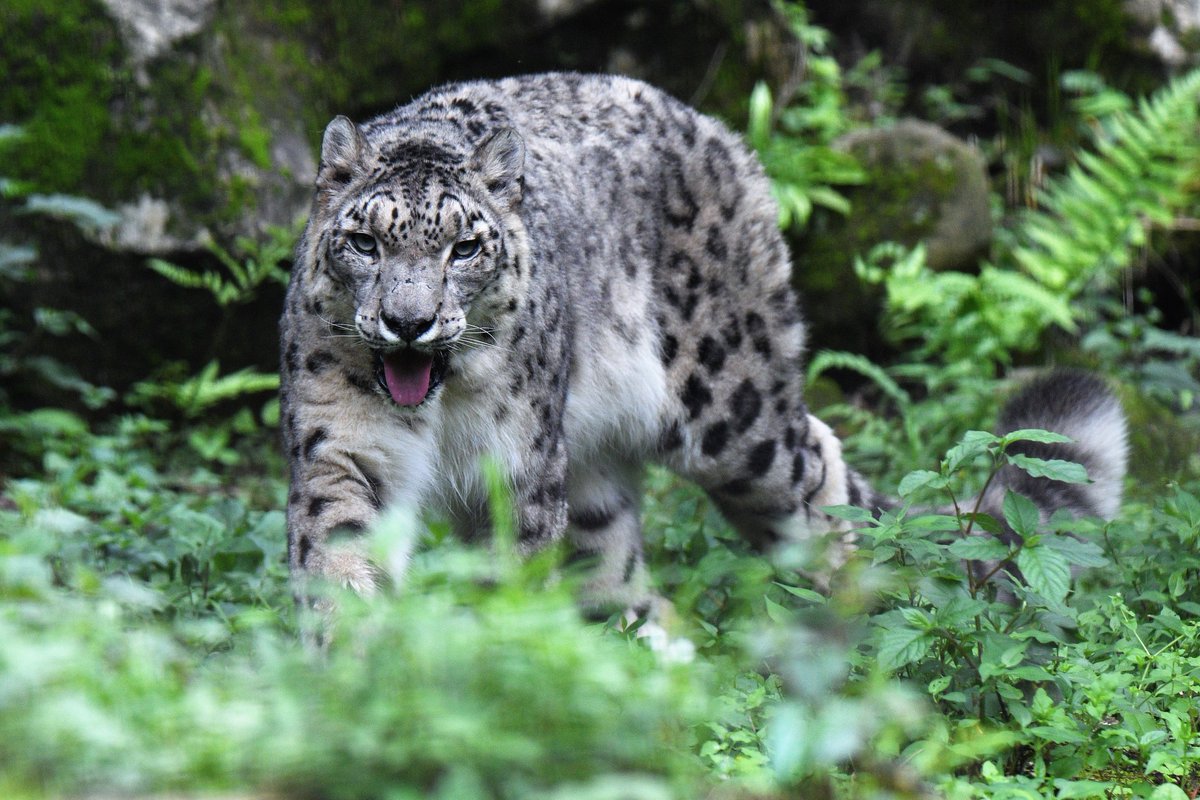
(655, 118, 897, 568)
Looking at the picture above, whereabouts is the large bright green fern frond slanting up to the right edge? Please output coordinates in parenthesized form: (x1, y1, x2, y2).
(857, 71, 1200, 369)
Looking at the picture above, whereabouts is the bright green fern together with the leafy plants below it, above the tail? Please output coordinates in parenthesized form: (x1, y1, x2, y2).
(815, 65, 1200, 474)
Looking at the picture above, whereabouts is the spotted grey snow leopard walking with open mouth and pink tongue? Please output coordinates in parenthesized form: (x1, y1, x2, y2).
(281, 73, 1120, 607)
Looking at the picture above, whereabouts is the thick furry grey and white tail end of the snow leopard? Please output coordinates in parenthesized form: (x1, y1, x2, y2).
(982, 369, 1129, 519)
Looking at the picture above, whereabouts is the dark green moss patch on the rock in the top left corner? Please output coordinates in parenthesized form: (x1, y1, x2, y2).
(0, 0, 229, 219)
